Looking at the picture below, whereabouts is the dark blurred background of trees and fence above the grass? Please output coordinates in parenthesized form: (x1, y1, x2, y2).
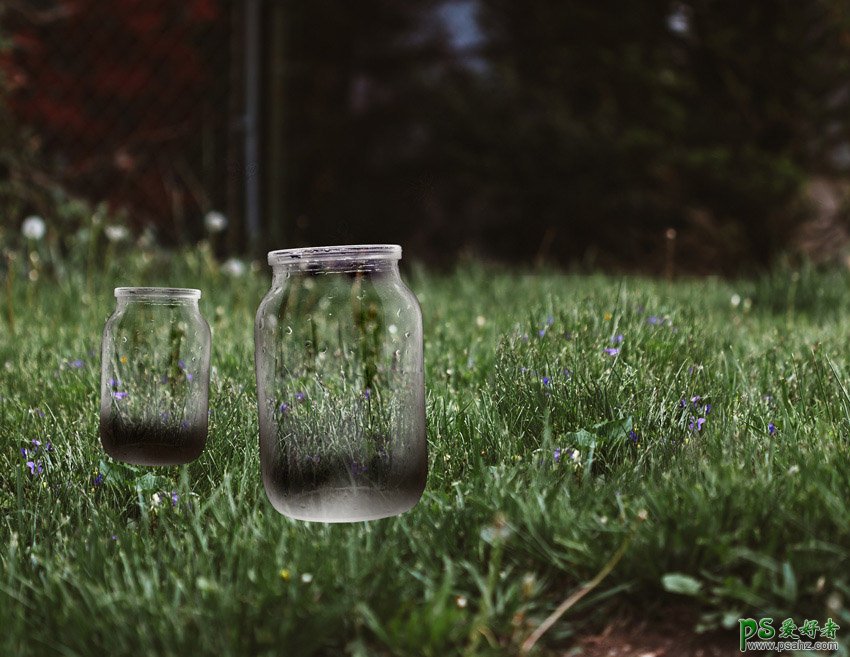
(0, 0, 850, 275)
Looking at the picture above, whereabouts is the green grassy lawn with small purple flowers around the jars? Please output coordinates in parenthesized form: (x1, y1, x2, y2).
(0, 251, 850, 657)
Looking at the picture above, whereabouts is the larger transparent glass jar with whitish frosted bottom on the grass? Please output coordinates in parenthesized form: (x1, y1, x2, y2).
(254, 245, 428, 522)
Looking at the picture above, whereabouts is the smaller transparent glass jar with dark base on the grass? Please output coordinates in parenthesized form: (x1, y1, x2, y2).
(100, 287, 211, 465)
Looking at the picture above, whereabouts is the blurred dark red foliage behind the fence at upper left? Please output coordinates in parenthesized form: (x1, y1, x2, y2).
(0, 0, 223, 231)
